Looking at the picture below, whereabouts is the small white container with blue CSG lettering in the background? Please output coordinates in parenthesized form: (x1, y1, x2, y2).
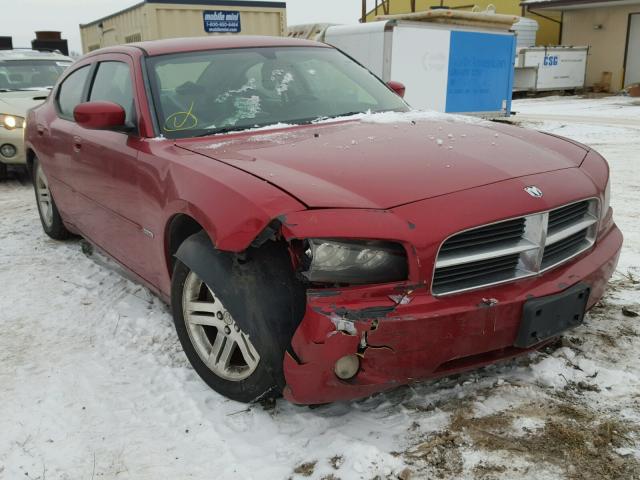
(513, 46, 589, 92)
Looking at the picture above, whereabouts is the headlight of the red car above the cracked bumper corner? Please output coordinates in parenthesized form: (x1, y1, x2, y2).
(301, 238, 408, 284)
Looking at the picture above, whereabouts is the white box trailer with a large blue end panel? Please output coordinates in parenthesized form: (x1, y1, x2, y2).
(318, 20, 516, 116)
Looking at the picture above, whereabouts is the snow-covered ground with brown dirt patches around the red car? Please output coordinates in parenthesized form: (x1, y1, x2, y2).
(0, 97, 640, 480)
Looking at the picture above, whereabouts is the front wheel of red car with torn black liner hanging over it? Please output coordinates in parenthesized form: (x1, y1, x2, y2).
(171, 233, 304, 403)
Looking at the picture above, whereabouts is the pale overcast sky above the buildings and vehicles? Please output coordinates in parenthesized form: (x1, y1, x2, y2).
(0, 0, 373, 52)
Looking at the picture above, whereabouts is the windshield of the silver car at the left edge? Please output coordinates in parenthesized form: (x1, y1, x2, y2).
(0, 60, 71, 91)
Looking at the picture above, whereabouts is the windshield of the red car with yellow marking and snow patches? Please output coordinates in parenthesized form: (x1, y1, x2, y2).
(150, 47, 408, 138)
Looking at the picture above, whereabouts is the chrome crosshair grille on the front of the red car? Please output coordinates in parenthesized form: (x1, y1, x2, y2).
(431, 199, 598, 295)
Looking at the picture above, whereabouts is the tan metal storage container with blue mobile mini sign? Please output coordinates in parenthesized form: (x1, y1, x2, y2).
(80, 0, 287, 53)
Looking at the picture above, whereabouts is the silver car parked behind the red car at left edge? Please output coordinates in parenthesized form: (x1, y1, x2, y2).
(0, 49, 73, 178)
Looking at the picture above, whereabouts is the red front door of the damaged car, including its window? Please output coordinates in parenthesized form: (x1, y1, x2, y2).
(75, 54, 149, 277)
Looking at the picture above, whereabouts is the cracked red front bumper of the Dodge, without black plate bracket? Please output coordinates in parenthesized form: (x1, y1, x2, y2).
(284, 225, 622, 404)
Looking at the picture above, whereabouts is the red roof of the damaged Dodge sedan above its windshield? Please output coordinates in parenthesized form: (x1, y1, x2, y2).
(91, 35, 331, 56)
